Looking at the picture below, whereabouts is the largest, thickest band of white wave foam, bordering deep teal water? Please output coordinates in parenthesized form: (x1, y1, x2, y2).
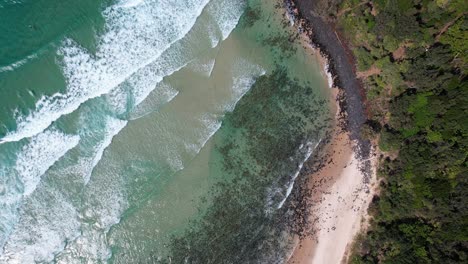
(3, 0, 208, 141)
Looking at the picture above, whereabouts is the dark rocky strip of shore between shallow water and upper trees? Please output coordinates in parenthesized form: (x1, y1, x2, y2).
(284, 0, 370, 144)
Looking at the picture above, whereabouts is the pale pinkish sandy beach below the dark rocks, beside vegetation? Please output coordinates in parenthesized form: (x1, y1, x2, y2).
(288, 89, 376, 264)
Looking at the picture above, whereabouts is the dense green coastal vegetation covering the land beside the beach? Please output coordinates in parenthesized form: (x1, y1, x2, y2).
(330, 0, 468, 263)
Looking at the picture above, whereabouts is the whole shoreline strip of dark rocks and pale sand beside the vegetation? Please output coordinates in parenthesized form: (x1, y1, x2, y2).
(285, 0, 377, 264)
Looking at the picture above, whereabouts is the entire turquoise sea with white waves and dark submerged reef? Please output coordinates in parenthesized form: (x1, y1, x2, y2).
(0, 0, 330, 263)
